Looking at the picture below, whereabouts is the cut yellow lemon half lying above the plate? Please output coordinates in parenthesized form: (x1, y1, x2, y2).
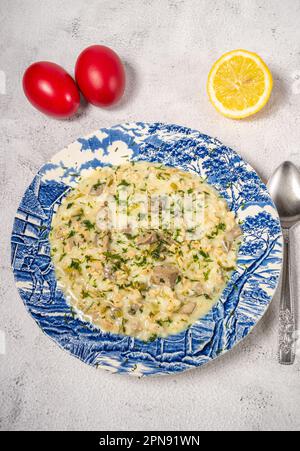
(207, 50, 273, 119)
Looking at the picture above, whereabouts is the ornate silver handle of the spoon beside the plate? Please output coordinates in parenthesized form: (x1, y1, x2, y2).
(279, 229, 296, 365)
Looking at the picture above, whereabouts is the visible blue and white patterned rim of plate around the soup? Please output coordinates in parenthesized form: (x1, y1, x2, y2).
(11, 122, 282, 376)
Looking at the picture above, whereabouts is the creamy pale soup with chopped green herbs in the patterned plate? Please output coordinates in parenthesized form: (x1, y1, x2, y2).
(50, 162, 242, 341)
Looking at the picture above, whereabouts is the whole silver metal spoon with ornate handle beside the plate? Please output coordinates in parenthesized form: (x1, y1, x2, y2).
(268, 161, 300, 365)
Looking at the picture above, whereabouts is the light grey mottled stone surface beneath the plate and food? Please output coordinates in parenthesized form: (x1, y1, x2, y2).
(0, 0, 300, 430)
